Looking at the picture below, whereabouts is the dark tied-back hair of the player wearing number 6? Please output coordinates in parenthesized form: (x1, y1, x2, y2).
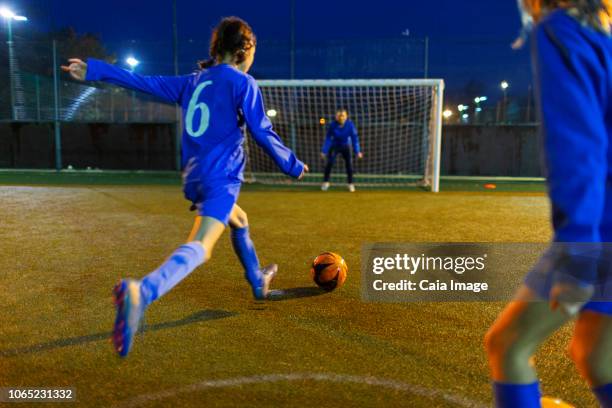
(198, 17, 257, 69)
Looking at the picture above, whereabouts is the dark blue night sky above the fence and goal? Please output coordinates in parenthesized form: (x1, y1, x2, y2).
(0, 0, 530, 107)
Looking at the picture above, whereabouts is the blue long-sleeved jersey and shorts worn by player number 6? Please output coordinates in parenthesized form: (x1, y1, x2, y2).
(86, 59, 304, 224)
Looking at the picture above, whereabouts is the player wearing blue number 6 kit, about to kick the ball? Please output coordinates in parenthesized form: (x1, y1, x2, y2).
(62, 17, 308, 357)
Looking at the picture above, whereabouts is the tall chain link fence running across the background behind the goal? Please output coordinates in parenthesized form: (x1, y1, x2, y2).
(0, 32, 536, 169)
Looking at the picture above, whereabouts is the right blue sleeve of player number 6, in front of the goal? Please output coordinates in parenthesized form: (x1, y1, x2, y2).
(242, 77, 304, 178)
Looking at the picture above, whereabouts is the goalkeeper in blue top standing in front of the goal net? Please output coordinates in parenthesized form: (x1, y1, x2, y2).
(321, 109, 363, 193)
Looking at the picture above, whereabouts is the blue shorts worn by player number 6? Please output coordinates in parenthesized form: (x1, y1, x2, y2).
(183, 179, 242, 225)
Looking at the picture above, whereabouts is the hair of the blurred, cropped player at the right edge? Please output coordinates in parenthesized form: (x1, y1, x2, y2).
(522, 0, 612, 34)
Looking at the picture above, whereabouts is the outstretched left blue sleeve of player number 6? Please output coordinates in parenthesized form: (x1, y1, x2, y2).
(85, 58, 193, 103)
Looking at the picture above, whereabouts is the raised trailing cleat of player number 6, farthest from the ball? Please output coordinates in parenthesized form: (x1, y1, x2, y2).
(113, 279, 145, 357)
